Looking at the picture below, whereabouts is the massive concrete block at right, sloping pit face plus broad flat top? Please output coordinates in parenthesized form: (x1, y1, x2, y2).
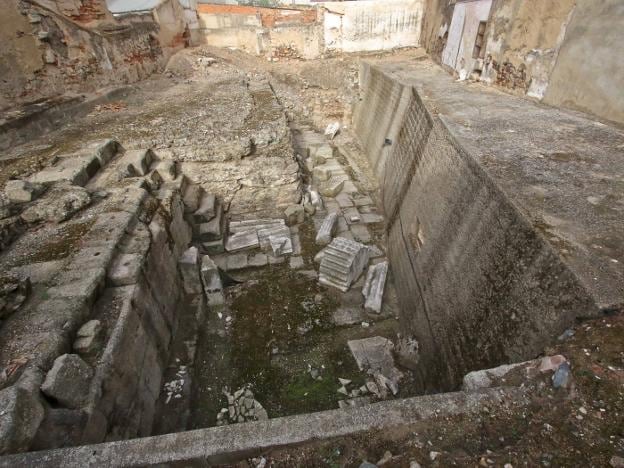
(355, 58, 624, 389)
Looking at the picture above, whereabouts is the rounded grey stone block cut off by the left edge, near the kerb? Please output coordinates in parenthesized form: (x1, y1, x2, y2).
(0, 385, 44, 455)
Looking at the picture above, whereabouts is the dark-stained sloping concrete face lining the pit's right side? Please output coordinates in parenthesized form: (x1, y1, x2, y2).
(354, 65, 596, 390)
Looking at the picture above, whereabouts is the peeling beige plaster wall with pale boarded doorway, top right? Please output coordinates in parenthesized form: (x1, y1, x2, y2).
(422, 0, 624, 123)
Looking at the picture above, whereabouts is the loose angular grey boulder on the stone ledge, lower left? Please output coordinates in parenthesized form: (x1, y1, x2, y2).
(41, 354, 93, 408)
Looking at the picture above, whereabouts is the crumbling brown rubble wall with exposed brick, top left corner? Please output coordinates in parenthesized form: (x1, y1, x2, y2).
(0, 0, 168, 108)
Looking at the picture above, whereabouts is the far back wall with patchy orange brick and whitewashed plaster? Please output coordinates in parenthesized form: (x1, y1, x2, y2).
(198, 0, 423, 59)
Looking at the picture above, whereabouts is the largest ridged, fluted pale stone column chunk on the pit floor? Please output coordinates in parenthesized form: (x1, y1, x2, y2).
(319, 237, 369, 292)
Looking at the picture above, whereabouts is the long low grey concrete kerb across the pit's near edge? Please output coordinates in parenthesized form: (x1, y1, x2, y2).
(0, 389, 527, 468)
